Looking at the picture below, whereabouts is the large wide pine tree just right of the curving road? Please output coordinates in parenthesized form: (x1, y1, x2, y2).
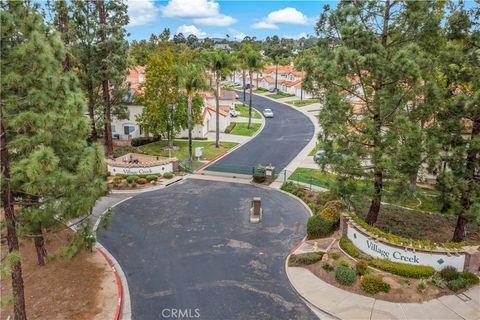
(307, 0, 442, 224)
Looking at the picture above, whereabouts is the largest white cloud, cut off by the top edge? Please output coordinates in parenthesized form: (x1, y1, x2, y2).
(161, 0, 237, 27)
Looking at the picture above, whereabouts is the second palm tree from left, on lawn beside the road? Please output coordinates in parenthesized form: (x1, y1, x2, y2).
(209, 50, 232, 148)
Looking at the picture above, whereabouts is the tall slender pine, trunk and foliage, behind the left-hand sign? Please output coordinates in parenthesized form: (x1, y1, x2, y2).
(96, 0, 128, 157)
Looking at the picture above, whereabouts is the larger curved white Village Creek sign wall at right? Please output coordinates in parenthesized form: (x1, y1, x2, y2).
(347, 225, 465, 271)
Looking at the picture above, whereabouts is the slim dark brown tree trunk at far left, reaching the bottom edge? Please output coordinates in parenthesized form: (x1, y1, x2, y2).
(0, 115, 27, 320)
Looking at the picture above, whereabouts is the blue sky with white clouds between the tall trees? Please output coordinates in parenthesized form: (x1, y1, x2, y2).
(127, 0, 336, 40)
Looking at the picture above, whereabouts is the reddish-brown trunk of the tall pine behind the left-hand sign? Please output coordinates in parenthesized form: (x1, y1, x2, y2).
(97, 0, 113, 157)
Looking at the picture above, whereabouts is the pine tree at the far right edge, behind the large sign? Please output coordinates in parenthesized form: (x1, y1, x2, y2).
(437, 3, 480, 242)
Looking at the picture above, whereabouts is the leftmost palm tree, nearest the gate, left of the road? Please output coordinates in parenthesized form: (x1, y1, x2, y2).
(180, 63, 206, 162)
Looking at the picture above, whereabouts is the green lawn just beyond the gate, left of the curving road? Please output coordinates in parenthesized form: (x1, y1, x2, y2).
(140, 140, 238, 160)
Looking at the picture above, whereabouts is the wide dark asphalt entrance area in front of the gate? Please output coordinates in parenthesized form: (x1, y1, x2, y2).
(98, 179, 316, 320)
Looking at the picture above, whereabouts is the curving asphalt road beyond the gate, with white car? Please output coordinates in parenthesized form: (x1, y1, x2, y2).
(205, 91, 315, 174)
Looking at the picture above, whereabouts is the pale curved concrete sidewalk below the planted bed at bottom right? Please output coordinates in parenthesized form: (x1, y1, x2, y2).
(287, 267, 480, 320)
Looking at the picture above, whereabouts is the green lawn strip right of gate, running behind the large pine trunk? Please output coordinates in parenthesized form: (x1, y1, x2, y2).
(290, 166, 441, 213)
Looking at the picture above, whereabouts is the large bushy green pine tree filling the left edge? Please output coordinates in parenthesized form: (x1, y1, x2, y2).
(1, 2, 106, 265)
